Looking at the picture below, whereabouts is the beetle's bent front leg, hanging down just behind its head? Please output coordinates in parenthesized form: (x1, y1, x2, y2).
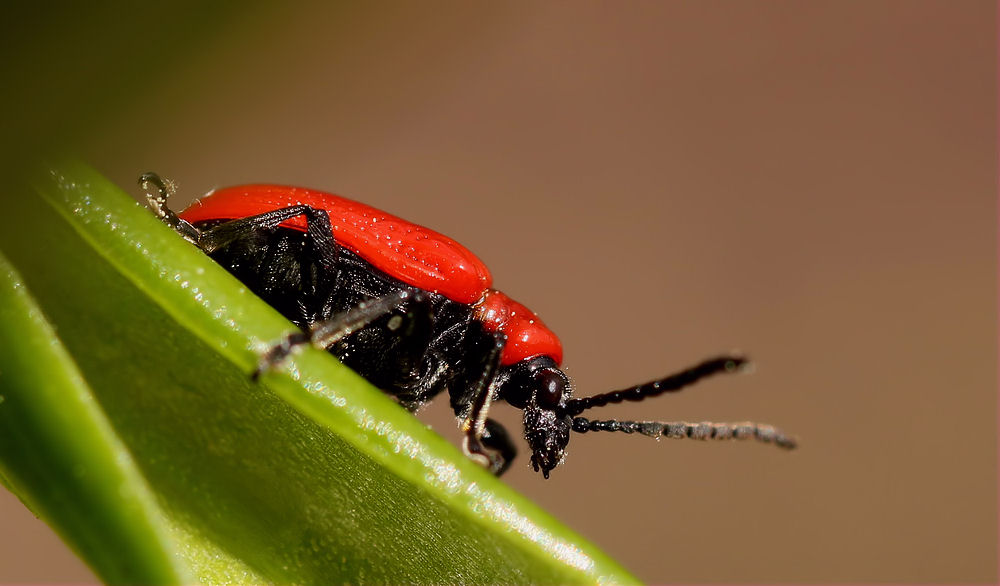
(462, 332, 509, 475)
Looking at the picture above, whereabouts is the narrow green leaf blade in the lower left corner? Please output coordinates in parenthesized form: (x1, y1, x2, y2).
(0, 255, 188, 584)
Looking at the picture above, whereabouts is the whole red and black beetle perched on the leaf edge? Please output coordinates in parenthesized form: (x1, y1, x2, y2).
(139, 173, 796, 478)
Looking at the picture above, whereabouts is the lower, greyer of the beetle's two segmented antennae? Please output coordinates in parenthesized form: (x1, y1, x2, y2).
(573, 417, 798, 450)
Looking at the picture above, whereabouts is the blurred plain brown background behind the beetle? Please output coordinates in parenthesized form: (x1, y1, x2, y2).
(0, 0, 997, 583)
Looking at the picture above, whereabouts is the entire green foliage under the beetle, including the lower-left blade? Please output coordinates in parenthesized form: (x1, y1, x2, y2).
(0, 164, 635, 583)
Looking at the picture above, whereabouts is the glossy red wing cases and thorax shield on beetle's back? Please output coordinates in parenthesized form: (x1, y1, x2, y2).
(178, 185, 562, 365)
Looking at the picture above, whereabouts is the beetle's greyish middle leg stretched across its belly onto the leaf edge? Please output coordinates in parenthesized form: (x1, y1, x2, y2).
(253, 289, 425, 380)
